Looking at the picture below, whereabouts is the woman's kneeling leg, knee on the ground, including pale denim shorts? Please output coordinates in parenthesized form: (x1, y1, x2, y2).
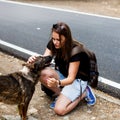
(54, 79, 87, 115)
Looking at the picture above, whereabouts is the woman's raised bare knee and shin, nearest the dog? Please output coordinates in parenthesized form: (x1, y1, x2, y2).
(40, 67, 61, 95)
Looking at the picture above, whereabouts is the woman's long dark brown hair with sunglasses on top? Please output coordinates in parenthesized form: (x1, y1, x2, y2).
(50, 22, 73, 61)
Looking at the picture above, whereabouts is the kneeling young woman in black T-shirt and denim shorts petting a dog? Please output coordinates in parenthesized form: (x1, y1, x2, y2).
(28, 22, 96, 115)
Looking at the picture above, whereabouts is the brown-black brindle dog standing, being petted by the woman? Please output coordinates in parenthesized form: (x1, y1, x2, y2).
(0, 56, 52, 120)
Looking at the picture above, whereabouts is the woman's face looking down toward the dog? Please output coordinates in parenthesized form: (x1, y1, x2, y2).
(52, 31, 65, 49)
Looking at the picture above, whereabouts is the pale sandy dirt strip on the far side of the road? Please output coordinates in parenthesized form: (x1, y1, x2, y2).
(13, 0, 120, 17)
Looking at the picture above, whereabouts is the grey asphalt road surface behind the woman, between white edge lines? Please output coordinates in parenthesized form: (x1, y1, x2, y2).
(0, 1, 120, 87)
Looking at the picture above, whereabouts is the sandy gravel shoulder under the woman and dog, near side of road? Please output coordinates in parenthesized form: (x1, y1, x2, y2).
(0, 52, 120, 120)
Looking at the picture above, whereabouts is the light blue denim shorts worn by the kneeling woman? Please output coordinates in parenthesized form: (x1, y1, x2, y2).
(57, 71, 87, 102)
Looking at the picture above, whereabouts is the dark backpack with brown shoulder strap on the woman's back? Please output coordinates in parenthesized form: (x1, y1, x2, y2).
(72, 41, 99, 88)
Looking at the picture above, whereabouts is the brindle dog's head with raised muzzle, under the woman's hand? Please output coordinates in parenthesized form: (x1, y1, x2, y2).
(25, 56, 52, 73)
